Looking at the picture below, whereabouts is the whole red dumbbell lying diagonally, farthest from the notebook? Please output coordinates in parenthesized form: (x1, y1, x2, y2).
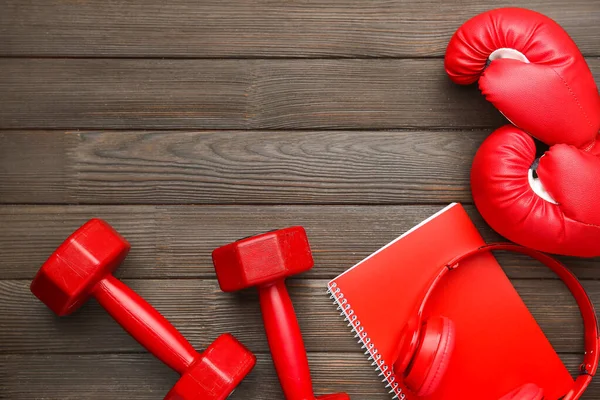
(31, 219, 256, 400)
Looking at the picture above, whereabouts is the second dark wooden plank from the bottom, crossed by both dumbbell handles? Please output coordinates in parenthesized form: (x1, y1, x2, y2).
(0, 279, 600, 354)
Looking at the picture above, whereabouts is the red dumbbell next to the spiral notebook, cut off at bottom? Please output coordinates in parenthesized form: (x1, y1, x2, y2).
(212, 226, 350, 400)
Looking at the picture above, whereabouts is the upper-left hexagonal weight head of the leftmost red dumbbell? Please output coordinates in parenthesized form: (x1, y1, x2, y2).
(31, 219, 131, 316)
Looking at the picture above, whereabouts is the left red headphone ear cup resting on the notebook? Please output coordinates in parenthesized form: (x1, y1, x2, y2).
(404, 316, 456, 397)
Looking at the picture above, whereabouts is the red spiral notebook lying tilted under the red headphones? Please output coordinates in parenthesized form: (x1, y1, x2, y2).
(328, 204, 573, 400)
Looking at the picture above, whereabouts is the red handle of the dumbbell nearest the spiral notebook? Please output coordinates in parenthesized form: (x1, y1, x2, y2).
(258, 280, 315, 400)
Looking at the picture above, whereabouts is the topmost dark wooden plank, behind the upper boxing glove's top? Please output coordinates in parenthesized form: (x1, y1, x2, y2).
(0, 0, 600, 57)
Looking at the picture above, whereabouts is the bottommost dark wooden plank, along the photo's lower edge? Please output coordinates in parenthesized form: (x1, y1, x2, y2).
(0, 353, 600, 400)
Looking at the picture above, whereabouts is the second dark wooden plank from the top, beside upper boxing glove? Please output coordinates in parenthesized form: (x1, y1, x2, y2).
(0, 58, 600, 129)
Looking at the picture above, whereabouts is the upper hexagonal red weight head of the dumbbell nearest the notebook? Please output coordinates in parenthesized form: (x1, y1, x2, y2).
(212, 226, 314, 292)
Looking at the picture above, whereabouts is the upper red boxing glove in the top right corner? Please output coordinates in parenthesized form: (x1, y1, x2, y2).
(445, 8, 600, 149)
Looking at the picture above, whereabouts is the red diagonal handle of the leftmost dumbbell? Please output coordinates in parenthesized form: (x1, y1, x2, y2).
(93, 275, 198, 375)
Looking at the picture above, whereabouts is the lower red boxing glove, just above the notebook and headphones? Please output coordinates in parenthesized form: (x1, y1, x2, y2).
(471, 125, 600, 257)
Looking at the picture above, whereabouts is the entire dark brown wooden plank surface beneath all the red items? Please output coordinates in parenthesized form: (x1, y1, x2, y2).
(0, 0, 600, 400)
